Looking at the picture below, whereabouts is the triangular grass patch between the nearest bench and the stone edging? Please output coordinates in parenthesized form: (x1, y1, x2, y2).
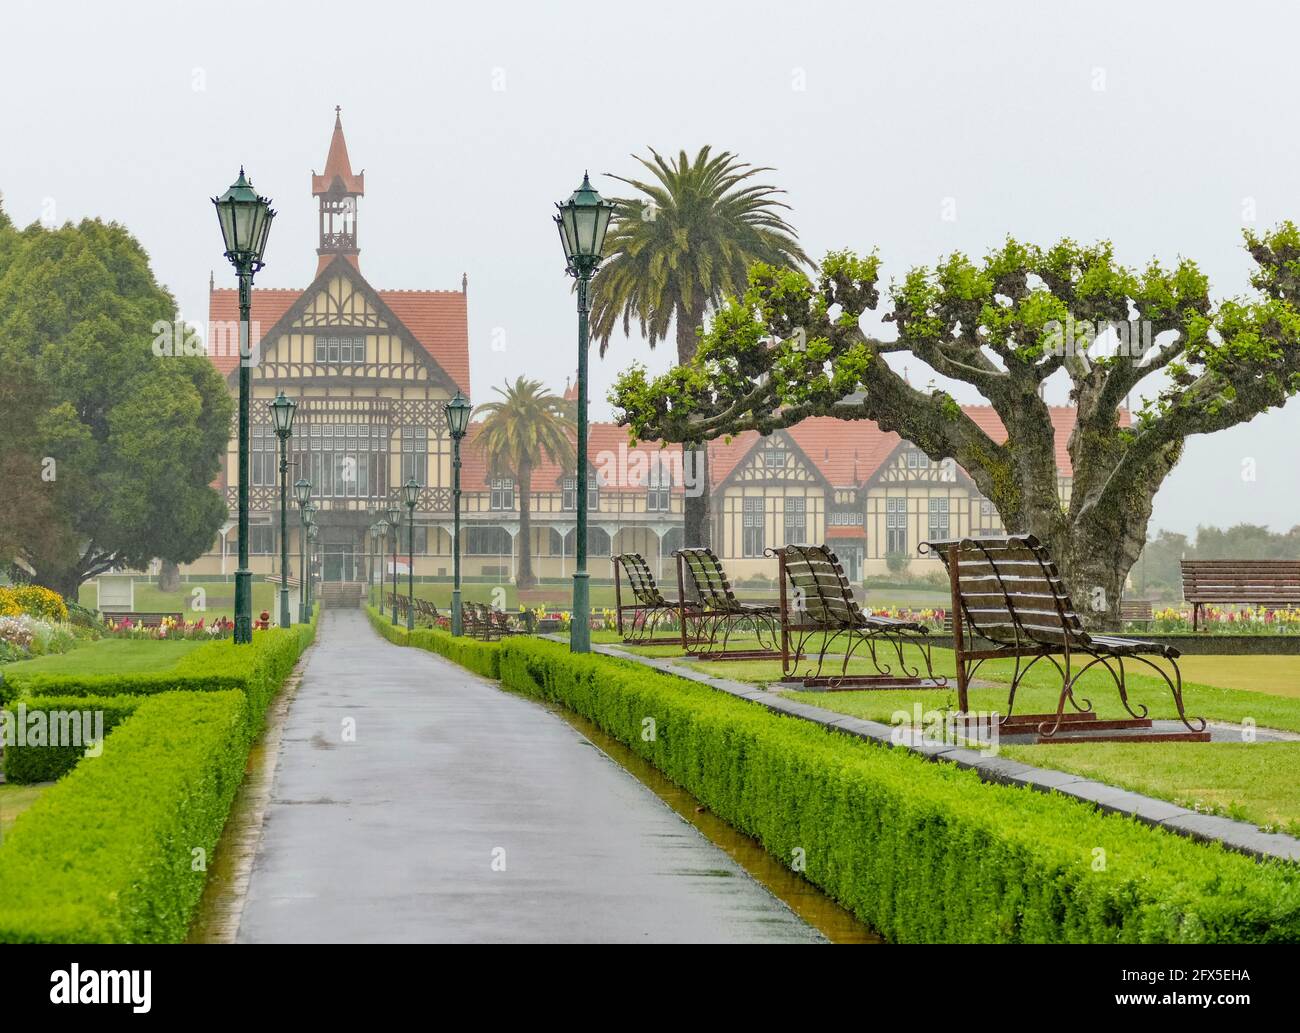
(1001, 742, 1300, 835)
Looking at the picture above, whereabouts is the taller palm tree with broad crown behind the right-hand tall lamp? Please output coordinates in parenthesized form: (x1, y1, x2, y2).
(592, 147, 809, 546)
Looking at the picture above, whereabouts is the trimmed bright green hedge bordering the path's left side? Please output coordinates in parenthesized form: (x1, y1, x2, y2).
(0, 620, 316, 943)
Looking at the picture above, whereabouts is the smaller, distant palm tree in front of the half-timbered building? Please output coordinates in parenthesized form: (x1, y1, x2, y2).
(475, 377, 581, 589)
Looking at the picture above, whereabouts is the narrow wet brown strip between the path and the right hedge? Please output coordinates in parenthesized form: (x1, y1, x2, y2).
(547, 706, 884, 943)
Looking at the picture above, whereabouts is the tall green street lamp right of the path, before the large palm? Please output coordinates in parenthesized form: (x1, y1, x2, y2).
(555, 173, 614, 652)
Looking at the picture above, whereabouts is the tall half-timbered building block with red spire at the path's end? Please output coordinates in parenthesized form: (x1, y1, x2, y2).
(186, 116, 469, 581)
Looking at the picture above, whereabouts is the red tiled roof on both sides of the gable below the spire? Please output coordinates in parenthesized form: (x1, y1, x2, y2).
(208, 287, 469, 395)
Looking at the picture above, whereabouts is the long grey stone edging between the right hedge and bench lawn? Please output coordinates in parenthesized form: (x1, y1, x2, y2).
(592, 644, 1300, 861)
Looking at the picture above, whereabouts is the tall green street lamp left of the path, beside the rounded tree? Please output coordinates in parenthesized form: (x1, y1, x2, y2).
(212, 169, 276, 643)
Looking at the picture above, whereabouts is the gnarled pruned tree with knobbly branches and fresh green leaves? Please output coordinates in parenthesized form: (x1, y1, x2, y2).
(611, 222, 1300, 619)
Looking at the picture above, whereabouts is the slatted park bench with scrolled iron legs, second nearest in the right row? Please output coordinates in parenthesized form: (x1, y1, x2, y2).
(767, 544, 948, 689)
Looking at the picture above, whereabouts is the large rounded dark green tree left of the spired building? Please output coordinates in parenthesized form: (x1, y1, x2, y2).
(0, 210, 231, 598)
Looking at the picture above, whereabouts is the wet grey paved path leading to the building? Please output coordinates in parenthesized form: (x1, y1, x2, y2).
(238, 609, 822, 943)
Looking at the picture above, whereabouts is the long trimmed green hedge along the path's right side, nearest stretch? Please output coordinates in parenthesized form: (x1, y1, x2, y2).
(497, 638, 1300, 943)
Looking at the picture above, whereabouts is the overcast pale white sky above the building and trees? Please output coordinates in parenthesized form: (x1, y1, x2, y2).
(0, 0, 1300, 540)
